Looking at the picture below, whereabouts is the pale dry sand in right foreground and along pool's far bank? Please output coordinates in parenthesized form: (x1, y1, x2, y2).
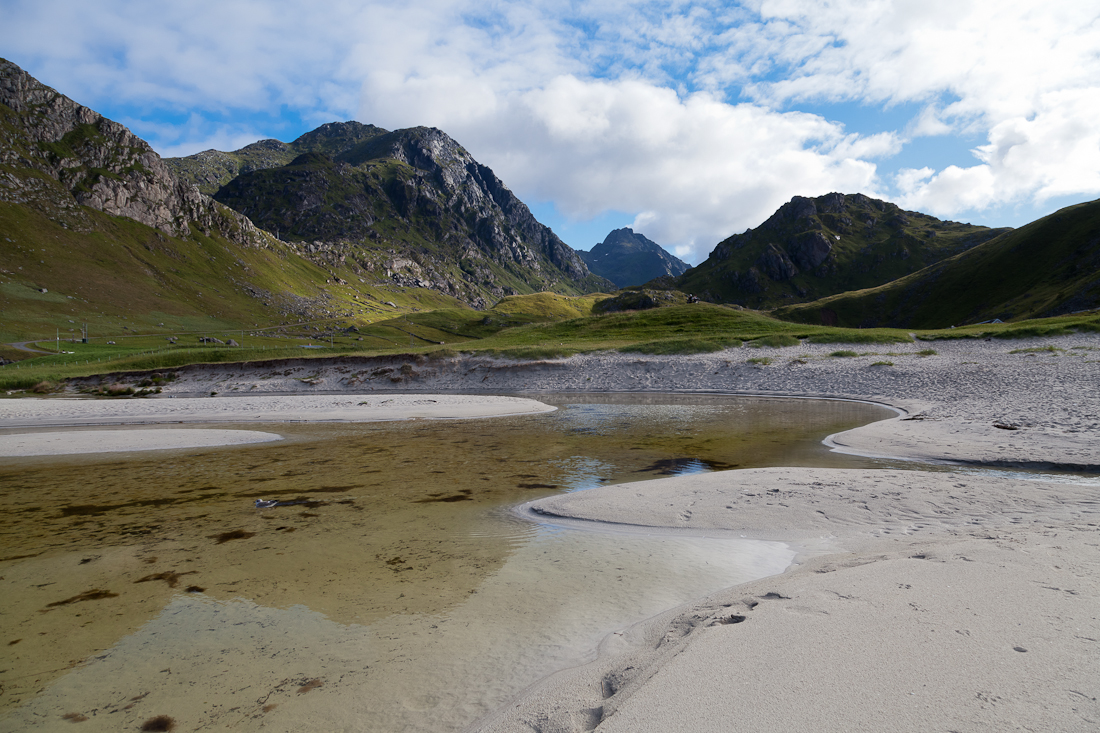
(8, 336, 1100, 733)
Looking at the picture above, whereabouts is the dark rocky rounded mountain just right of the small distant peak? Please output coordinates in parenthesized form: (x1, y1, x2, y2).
(677, 194, 1009, 308)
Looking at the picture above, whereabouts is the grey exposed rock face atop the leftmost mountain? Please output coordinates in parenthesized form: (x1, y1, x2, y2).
(0, 59, 272, 244)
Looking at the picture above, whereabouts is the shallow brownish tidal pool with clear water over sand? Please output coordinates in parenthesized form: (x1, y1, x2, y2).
(0, 395, 892, 731)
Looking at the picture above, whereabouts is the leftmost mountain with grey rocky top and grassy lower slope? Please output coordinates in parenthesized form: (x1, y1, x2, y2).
(0, 59, 468, 341)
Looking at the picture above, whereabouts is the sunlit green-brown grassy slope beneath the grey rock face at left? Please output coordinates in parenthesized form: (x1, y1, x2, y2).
(0, 203, 463, 347)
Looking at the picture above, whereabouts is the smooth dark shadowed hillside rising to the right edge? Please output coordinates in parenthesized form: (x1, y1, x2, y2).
(776, 200, 1100, 328)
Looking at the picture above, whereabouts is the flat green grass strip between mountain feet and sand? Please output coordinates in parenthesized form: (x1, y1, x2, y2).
(0, 294, 1100, 391)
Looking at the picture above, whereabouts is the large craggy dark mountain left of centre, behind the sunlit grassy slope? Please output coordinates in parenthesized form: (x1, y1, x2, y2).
(168, 122, 615, 308)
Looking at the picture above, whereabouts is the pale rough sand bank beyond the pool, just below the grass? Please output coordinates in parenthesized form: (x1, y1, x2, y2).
(116, 327, 1100, 469)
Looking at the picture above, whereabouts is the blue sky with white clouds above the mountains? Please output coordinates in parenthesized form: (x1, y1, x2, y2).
(0, 0, 1100, 264)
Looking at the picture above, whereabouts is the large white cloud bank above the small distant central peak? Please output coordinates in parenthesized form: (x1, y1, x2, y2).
(363, 76, 897, 262)
